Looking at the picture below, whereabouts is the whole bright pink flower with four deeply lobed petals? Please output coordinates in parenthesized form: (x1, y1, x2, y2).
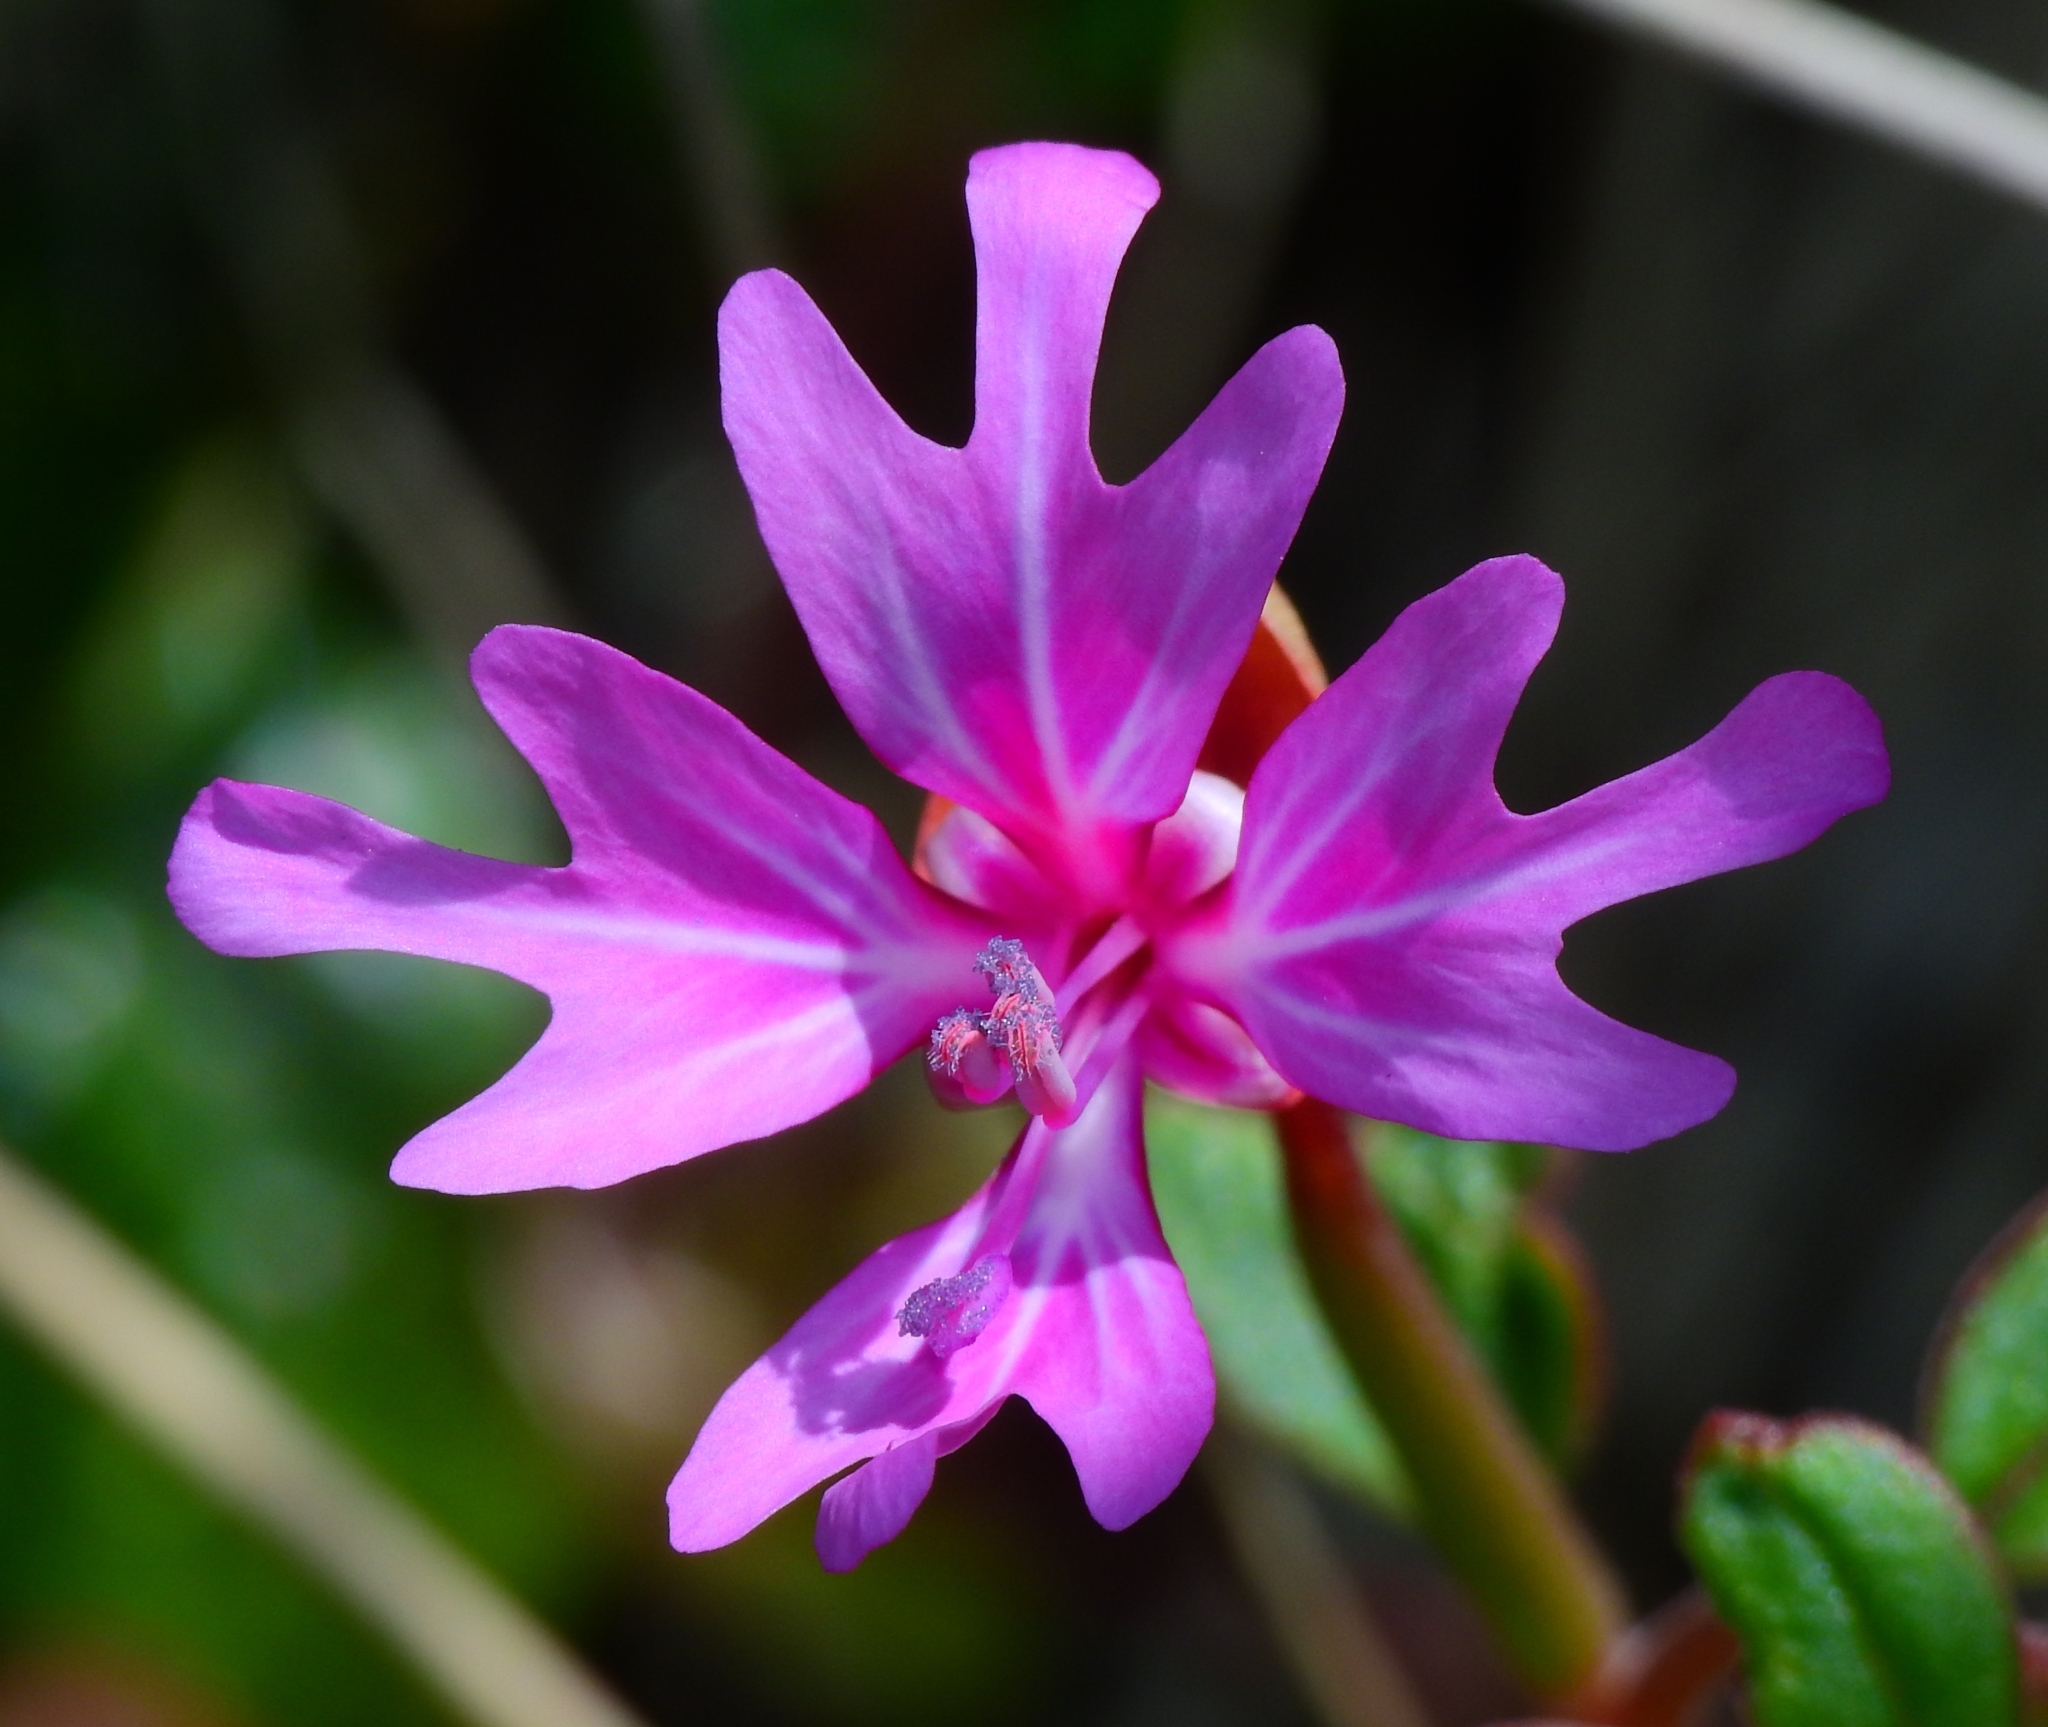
(170, 143, 1886, 1569)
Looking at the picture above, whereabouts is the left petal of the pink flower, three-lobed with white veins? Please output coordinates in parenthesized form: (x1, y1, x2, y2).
(170, 627, 991, 1192)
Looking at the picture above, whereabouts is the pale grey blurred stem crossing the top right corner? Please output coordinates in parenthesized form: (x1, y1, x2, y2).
(1552, 0, 2048, 209)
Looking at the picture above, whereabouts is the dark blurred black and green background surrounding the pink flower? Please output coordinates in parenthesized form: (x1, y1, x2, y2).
(0, 0, 2048, 1727)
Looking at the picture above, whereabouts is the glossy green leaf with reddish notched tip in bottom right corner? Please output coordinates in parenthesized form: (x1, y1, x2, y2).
(1679, 1414, 2019, 1727)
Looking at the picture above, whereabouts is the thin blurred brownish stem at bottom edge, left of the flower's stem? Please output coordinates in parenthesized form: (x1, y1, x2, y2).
(1202, 1420, 1430, 1727)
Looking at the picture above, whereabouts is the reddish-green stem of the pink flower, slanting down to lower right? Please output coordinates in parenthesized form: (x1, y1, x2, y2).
(1278, 1098, 1622, 1702)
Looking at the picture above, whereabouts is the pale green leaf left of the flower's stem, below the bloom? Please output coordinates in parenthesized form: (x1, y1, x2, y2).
(1145, 1092, 1409, 1516)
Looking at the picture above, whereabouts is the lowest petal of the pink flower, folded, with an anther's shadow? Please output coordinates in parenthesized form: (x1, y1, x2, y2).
(670, 1061, 1214, 1563)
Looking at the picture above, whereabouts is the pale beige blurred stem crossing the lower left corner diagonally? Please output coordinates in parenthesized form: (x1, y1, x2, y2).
(0, 1149, 641, 1727)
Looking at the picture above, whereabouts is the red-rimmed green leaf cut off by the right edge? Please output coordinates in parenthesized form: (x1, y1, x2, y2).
(1923, 1203, 2048, 1582)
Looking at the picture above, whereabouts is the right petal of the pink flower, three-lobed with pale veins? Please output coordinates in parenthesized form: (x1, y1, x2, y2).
(1165, 557, 1888, 1151)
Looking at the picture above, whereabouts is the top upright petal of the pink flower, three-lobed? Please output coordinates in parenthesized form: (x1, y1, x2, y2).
(719, 143, 1343, 877)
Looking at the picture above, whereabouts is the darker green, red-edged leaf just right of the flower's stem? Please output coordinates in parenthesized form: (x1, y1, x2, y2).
(1366, 1123, 1602, 1465)
